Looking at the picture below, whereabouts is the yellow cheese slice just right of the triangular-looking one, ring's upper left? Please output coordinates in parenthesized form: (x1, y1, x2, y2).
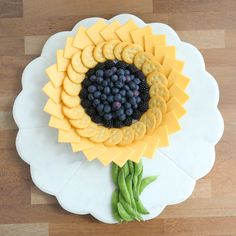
(86, 20, 107, 45)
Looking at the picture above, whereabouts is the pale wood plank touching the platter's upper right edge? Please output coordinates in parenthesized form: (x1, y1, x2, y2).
(177, 30, 225, 49)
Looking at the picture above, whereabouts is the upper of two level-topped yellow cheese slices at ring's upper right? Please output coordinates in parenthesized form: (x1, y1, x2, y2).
(144, 34, 166, 54)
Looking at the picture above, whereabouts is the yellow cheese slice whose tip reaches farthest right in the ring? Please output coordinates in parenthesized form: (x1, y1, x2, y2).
(168, 70, 190, 89)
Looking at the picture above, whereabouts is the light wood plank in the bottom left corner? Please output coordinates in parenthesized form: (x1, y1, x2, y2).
(0, 223, 49, 236)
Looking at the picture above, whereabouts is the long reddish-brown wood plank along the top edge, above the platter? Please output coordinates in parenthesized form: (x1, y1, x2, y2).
(24, 0, 153, 17)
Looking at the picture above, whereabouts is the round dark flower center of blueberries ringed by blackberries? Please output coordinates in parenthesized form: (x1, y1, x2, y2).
(79, 60, 150, 128)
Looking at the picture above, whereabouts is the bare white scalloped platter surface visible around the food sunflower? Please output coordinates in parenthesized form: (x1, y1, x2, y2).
(13, 14, 224, 223)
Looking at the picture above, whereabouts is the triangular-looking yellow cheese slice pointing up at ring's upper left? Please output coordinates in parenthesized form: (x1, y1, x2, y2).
(73, 26, 93, 49)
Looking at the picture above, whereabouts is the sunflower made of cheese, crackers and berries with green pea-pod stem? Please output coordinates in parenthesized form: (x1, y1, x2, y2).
(42, 19, 190, 222)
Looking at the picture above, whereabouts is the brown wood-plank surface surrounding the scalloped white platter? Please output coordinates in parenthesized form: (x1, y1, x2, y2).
(0, 0, 236, 236)
